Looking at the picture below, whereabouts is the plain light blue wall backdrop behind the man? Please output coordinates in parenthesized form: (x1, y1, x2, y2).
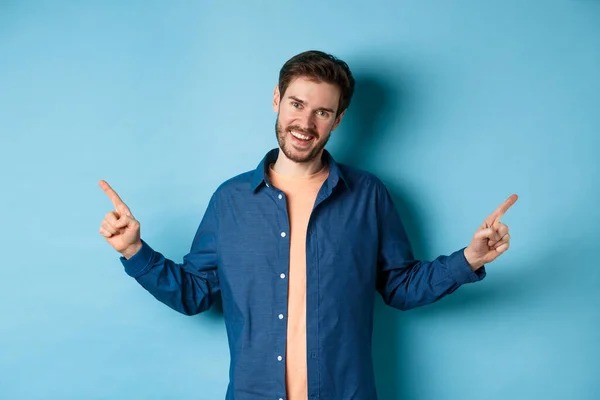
(0, 0, 600, 400)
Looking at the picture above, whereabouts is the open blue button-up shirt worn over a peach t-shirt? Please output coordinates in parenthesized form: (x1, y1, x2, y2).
(121, 149, 485, 400)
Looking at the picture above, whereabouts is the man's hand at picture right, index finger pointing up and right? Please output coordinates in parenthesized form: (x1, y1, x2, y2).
(465, 194, 518, 271)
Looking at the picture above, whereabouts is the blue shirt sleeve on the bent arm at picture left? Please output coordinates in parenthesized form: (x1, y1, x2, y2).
(120, 194, 220, 315)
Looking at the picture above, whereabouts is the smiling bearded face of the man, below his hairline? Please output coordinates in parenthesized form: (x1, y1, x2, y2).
(273, 77, 343, 163)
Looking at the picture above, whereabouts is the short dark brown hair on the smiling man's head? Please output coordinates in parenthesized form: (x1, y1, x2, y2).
(279, 50, 354, 117)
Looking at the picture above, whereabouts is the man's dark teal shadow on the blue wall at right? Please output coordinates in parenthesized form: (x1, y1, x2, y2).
(344, 64, 574, 399)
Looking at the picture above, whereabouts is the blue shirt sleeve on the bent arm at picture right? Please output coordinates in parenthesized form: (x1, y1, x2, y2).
(376, 183, 486, 310)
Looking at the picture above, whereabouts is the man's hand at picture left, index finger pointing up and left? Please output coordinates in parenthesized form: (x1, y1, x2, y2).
(99, 181, 142, 259)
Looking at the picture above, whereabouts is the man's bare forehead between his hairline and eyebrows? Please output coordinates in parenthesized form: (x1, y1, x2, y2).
(285, 77, 341, 110)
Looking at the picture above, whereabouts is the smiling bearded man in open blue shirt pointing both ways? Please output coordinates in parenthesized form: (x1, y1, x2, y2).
(100, 51, 517, 400)
